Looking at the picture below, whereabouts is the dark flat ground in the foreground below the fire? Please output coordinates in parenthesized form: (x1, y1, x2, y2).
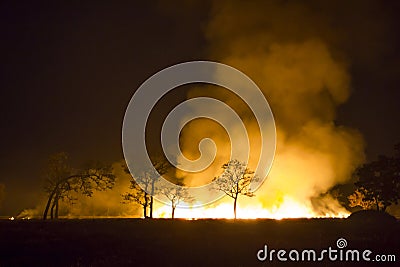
(0, 219, 400, 266)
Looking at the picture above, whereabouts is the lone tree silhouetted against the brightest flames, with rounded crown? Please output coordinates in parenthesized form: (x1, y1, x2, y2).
(213, 159, 259, 219)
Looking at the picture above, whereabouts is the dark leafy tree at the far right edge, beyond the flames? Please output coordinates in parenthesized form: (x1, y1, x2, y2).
(355, 145, 400, 211)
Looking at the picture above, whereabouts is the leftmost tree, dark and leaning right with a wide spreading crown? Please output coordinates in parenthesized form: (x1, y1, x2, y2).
(43, 152, 115, 220)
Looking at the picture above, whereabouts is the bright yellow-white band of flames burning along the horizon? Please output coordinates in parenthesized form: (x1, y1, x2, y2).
(154, 197, 349, 220)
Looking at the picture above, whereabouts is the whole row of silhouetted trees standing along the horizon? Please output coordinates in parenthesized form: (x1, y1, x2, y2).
(43, 144, 400, 222)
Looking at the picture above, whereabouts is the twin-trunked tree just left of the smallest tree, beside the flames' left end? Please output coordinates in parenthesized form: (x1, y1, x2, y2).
(122, 157, 170, 218)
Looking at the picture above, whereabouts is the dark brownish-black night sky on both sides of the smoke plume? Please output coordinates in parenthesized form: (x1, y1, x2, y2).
(0, 1, 400, 215)
